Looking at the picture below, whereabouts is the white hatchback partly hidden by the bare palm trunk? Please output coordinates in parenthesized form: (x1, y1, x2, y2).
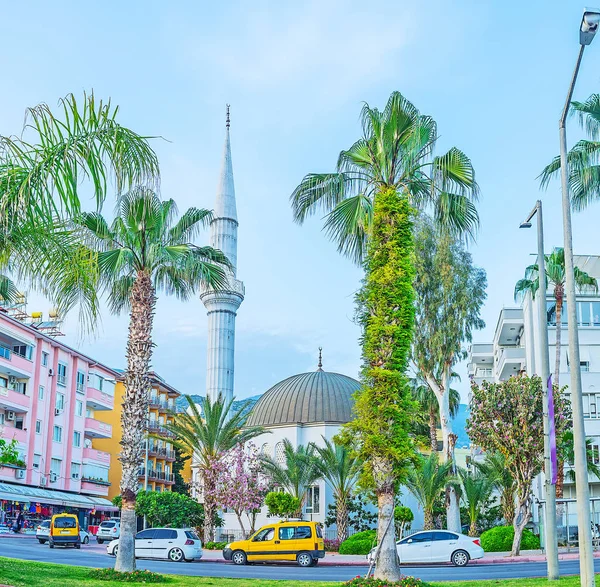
(106, 528, 202, 563)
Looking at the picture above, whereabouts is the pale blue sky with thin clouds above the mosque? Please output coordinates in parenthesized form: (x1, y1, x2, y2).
(0, 0, 600, 399)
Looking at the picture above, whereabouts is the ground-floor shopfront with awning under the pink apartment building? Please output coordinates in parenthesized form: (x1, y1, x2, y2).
(0, 483, 119, 532)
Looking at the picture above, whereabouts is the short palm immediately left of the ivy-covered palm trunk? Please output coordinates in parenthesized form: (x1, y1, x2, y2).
(313, 436, 361, 541)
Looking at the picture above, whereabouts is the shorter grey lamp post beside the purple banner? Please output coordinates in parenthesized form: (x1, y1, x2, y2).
(519, 200, 559, 581)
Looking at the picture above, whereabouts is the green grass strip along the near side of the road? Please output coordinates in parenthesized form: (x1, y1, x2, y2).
(0, 558, 596, 587)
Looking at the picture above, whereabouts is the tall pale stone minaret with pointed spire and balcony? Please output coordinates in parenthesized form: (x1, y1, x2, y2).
(200, 104, 244, 401)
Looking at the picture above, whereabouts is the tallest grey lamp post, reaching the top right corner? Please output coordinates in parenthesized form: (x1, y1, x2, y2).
(558, 8, 600, 587)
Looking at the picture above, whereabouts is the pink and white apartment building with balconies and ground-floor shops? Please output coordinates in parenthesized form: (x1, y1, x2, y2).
(0, 311, 118, 526)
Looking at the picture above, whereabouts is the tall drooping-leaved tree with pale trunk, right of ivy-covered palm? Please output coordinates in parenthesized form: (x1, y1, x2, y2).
(412, 217, 487, 532)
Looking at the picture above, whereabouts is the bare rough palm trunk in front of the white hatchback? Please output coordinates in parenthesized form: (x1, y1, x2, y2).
(115, 272, 156, 572)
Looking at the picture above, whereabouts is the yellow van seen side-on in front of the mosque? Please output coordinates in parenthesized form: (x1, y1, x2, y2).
(223, 520, 325, 567)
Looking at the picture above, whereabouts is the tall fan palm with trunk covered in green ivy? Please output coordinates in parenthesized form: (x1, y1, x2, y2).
(291, 92, 478, 581)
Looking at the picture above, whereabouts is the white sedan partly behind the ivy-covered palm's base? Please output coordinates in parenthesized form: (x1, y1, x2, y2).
(367, 530, 483, 567)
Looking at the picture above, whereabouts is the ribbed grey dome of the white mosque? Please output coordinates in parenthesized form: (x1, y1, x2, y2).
(246, 369, 360, 426)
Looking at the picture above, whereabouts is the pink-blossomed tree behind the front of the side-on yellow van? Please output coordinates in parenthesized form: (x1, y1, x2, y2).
(216, 443, 269, 536)
